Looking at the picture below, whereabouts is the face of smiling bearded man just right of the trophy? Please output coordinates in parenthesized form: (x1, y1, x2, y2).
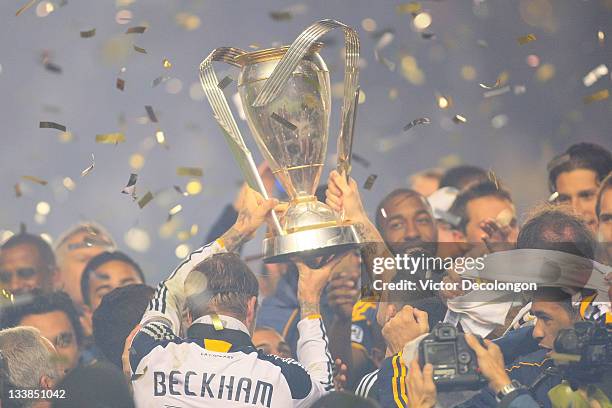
(381, 194, 437, 253)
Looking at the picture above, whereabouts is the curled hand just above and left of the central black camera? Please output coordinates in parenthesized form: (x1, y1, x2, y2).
(382, 305, 429, 354)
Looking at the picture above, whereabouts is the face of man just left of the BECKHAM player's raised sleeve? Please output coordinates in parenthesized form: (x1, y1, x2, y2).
(89, 261, 144, 312)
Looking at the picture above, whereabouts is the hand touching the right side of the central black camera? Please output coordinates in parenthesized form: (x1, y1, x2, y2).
(465, 333, 511, 393)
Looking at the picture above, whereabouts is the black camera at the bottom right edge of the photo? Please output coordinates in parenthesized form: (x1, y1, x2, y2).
(551, 321, 612, 388)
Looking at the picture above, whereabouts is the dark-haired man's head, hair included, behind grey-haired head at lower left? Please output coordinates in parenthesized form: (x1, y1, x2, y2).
(3, 292, 83, 372)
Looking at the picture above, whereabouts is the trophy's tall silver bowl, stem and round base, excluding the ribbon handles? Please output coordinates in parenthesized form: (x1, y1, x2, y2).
(236, 43, 359, 263)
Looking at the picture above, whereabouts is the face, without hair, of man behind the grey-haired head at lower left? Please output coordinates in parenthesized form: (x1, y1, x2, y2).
(19, 310, 79, 372)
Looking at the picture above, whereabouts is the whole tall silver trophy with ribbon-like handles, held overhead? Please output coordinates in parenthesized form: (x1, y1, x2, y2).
(200, 20, 360, 263)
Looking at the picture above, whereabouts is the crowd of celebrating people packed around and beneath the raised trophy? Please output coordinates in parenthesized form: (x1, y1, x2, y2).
(0, 143, 612, 408)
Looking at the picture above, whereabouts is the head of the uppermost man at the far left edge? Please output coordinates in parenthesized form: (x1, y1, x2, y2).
(0, 232, 57, 295)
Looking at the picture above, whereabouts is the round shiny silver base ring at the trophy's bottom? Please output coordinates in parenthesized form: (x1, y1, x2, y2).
(263, 224, 361, 263)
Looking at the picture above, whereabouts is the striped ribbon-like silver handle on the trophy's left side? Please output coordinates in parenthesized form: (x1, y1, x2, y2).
(200, 47, 285, 235)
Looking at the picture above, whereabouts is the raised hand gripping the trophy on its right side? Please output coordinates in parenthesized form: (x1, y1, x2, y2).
(325, 170, 368, 222)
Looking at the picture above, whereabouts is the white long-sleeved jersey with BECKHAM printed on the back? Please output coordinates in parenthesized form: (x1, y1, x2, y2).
(130, 242, 333, 408)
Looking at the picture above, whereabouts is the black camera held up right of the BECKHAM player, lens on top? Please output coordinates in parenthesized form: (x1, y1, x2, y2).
(419, 323, 487, 391)
